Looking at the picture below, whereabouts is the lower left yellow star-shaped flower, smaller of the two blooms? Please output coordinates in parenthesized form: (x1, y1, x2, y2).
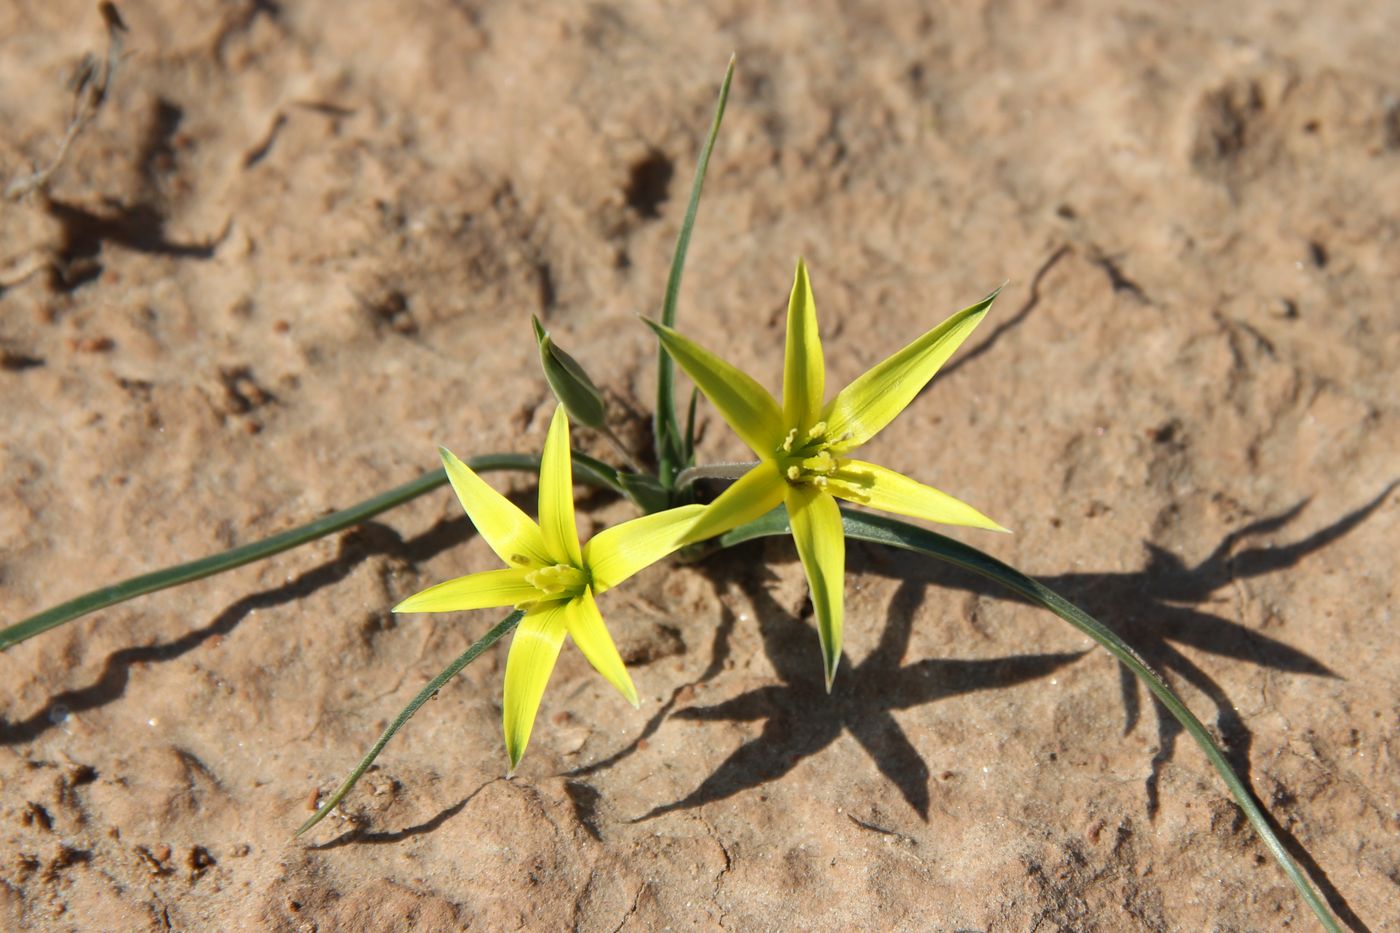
(393, 406, 703, 773)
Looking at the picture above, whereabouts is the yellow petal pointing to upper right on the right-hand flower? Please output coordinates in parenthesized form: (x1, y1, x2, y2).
(820, 289, 1001, 450)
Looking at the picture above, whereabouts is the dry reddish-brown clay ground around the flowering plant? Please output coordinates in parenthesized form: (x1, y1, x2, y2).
(0, 0, 1400, 933)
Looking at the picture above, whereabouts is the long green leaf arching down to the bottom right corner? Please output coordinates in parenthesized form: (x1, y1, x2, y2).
(718, 509, 1341, 933)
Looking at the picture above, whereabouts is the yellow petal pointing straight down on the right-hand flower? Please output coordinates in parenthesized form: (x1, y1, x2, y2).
(787, 483, 846, 693)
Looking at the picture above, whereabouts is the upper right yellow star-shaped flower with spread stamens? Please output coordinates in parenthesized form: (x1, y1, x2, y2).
(647, 261, 1007, 691)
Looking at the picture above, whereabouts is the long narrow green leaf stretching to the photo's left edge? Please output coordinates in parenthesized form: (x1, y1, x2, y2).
(0, 452, 627, 651)
